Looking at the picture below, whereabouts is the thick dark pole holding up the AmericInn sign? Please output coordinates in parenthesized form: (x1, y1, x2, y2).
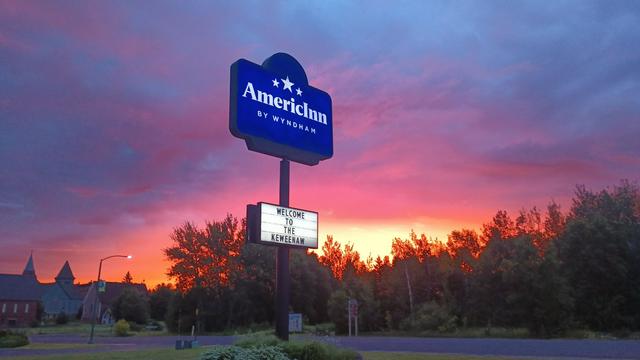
(276, 159, 290, 341)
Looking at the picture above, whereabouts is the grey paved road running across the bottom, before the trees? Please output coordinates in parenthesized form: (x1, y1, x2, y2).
(0, 335, 640, 359)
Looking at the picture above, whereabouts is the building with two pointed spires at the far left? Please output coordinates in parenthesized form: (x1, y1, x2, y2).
(0, 254, 88, 327)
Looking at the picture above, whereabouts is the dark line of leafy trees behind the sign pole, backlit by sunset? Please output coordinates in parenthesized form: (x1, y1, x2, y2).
(150, 181, 640, 336)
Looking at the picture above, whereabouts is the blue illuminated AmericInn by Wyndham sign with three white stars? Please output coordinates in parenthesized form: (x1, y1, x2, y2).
(229, 53, 333, 165)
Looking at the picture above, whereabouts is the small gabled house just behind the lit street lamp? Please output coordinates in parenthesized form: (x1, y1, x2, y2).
(82, 282, 149, 324)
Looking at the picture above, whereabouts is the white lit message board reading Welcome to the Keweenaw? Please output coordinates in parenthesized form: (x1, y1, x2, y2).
(247, 202, 318, 249)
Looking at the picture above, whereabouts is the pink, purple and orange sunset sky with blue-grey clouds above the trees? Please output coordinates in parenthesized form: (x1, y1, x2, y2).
(0, 0, 640, 285)
